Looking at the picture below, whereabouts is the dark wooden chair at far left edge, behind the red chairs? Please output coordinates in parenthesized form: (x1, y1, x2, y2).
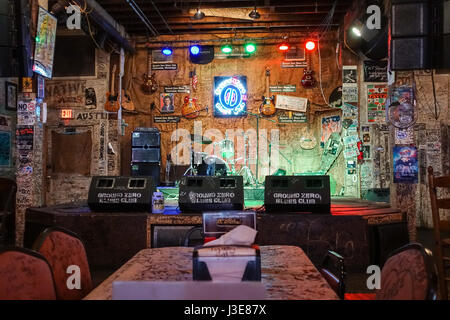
(0, 178, 17, 245)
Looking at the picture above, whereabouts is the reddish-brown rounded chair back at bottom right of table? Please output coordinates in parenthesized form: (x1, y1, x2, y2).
(376, 243, 437, 300)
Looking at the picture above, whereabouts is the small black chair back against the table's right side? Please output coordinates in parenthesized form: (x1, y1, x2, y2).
(320, 251, 345, 299)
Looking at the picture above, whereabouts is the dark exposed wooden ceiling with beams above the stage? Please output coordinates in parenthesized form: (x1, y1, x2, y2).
(50, 0, 353, 37)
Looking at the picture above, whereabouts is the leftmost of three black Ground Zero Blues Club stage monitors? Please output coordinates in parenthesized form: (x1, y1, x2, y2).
(88, 176, 156, 212)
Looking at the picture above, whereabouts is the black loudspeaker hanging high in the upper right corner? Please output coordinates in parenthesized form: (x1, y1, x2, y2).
(390, 0, 431, 70)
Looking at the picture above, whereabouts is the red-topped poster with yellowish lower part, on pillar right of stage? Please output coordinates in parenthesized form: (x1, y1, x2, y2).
(367, 85, 388, 123)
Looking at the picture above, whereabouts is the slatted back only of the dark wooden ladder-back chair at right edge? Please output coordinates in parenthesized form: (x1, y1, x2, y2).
(428, 166, 450, 239)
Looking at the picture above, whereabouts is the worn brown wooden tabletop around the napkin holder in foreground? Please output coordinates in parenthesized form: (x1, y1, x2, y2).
(85, 246, 338, 300)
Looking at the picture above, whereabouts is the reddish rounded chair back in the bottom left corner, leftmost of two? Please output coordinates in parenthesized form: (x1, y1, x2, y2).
(0, 247, 56, 300)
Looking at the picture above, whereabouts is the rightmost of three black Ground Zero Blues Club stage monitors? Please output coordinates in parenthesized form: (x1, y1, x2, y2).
(264, 176, 331, 213)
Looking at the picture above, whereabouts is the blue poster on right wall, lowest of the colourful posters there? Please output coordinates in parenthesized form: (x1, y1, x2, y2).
(394, 146, 419, 183)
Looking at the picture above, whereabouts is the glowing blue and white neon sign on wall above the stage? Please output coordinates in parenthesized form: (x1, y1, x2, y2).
(214, 76, 247, 117)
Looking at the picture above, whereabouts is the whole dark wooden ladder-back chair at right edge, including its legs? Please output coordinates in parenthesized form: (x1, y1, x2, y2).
(428, 167, 450, 300)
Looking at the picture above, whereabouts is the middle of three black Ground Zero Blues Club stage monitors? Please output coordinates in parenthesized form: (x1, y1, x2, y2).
(178, 176, 244, 212)
